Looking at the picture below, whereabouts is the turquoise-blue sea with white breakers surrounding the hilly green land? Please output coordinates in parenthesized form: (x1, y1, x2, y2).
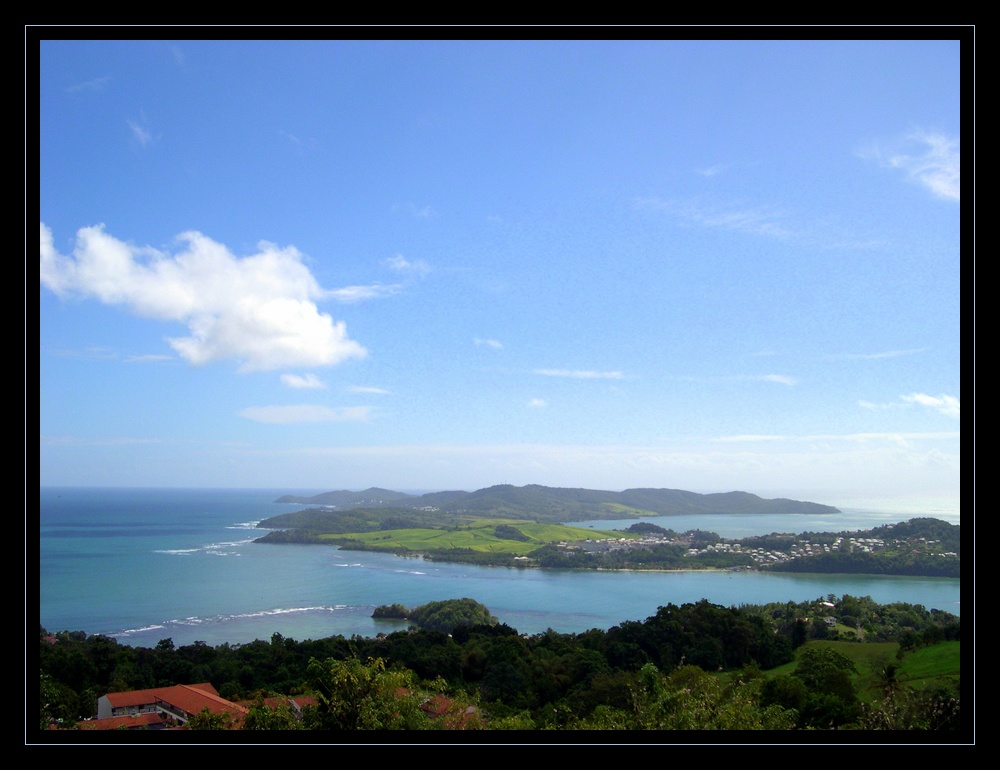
(37, 487, 960, 647)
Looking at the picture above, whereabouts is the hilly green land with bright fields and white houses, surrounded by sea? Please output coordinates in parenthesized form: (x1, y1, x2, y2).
(256, 485, 961, 577)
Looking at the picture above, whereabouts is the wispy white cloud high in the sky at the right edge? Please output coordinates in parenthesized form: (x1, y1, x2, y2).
(858, 131, 962, 202)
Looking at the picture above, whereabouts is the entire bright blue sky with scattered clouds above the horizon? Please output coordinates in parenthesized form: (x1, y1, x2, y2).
(37, 40, 960, 502)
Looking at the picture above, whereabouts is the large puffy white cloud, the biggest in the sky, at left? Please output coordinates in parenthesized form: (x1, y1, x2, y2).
(40, 223, 367, 371)
